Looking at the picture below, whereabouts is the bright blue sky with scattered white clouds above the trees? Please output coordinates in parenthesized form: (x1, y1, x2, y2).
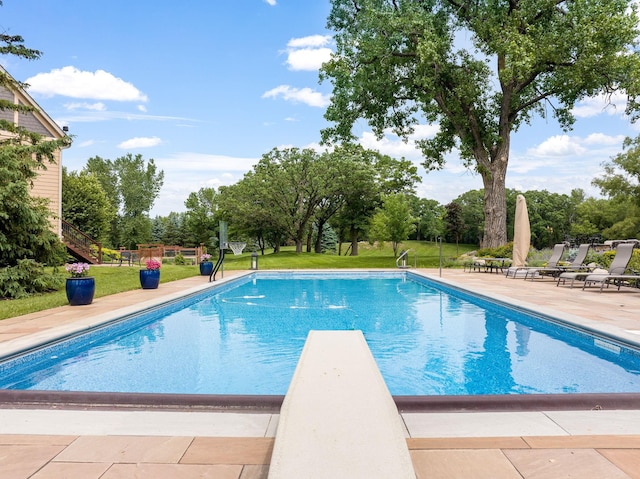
(0, 0, 638, 216)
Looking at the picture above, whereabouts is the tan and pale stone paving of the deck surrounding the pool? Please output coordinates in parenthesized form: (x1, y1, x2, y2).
(0, 270, 640, 479)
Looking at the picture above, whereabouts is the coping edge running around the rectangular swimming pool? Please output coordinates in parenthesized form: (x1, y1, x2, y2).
(0, 269, 640, 413)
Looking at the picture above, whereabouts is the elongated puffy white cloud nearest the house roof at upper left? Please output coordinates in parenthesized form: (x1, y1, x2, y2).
(26, 66, 147, 102)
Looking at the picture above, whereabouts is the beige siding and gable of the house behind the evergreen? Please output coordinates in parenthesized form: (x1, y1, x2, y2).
(0, 67, 66, 236)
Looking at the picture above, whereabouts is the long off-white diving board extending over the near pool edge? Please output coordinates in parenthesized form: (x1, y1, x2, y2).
(269, 331, 416, 479)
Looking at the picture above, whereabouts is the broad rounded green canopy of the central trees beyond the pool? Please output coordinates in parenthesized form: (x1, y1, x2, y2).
(219, 147, 419, 255)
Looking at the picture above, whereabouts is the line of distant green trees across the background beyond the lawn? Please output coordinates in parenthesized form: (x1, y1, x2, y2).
(63, 139, 640, 255)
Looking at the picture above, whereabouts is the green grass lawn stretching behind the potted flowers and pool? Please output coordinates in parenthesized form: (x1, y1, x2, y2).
(0, 241, 475, 319)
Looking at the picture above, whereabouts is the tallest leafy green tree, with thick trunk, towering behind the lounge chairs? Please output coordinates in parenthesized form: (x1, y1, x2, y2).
(321, 0, 640, 247)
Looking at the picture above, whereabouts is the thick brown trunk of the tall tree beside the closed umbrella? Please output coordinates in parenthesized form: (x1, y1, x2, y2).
(481, 152, 509, 248)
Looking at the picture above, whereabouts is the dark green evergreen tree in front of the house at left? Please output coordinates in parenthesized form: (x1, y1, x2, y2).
(0, 29, 70, 297)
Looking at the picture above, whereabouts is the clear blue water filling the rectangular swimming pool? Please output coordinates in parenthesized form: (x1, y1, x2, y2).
(0, 272, 640, 395)
